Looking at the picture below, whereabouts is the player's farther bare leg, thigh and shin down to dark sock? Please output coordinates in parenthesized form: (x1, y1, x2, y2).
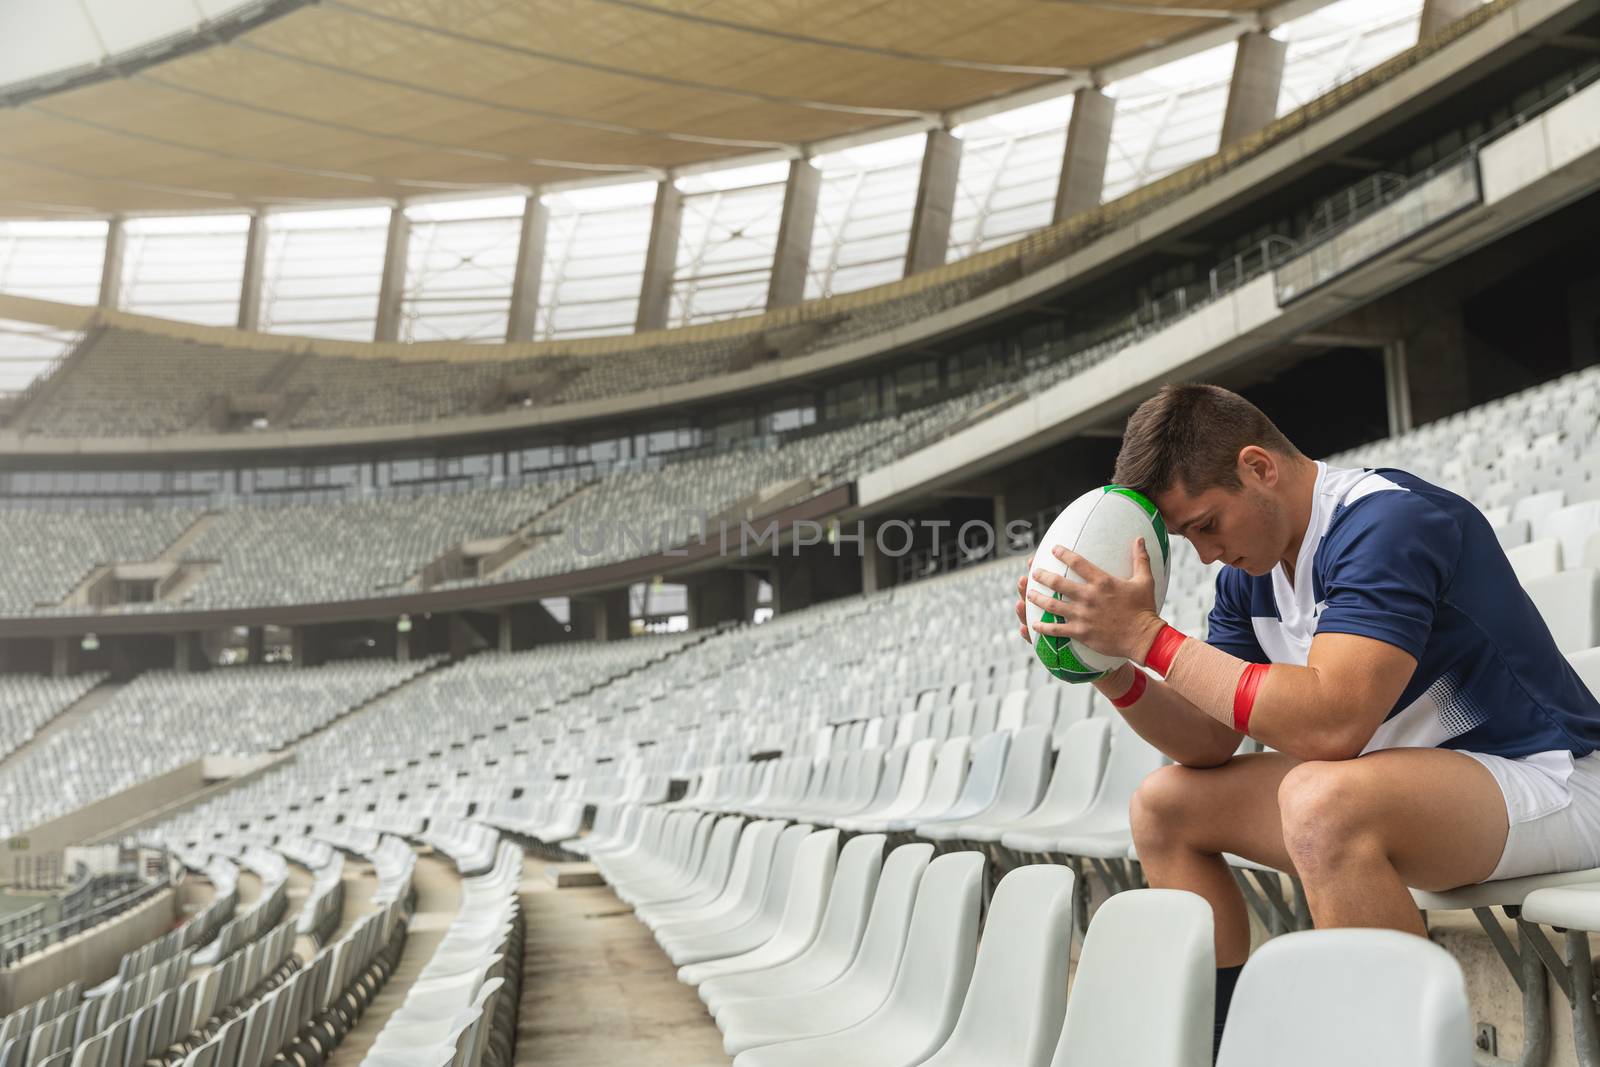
(1130, 752, 1299, 968)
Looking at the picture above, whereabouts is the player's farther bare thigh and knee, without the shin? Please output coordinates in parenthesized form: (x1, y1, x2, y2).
(1133, 752, 1301, 870)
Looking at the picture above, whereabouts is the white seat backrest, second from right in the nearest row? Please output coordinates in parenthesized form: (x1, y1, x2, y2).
(1051, 889, 1216, 1067)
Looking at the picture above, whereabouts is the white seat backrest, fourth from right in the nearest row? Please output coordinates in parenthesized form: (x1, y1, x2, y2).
(869, 853, 1003, 1064)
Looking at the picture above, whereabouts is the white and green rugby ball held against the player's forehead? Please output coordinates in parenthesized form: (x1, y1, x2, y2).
(1027, 485, 1171, 681)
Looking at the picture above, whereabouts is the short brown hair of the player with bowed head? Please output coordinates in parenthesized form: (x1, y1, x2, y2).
(1112, 382, 1299, 496)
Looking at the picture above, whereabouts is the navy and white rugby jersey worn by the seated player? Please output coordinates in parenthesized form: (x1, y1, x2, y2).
(1206, 462, 1600, 758)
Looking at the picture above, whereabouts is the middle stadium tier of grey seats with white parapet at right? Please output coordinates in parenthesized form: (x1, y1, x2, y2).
(0, 47, 1600, 652)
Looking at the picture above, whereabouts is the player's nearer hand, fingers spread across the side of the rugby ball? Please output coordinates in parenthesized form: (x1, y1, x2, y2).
(1024, 537, 1163, 662)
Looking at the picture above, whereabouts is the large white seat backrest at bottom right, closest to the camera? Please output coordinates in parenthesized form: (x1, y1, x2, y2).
(1216, 929, 1472, 1067)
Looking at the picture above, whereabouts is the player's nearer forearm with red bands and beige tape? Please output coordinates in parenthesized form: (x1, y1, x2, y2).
(1146, 627, 1371, 760)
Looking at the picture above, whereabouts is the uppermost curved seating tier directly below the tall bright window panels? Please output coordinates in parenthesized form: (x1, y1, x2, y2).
(0, 0, 1581, 458)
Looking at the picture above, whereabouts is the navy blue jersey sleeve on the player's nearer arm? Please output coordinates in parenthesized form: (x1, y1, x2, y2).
(1317, 490, 1461, 659)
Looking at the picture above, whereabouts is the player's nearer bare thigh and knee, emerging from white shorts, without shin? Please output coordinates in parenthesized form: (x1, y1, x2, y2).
(1280, 749, 1509, 889)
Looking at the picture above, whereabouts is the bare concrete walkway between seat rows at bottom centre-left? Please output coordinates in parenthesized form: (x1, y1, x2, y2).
(515, 859, 730, 1067)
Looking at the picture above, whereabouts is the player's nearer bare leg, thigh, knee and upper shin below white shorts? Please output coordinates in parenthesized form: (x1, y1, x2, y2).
(1277, 749, 1509, 934)
